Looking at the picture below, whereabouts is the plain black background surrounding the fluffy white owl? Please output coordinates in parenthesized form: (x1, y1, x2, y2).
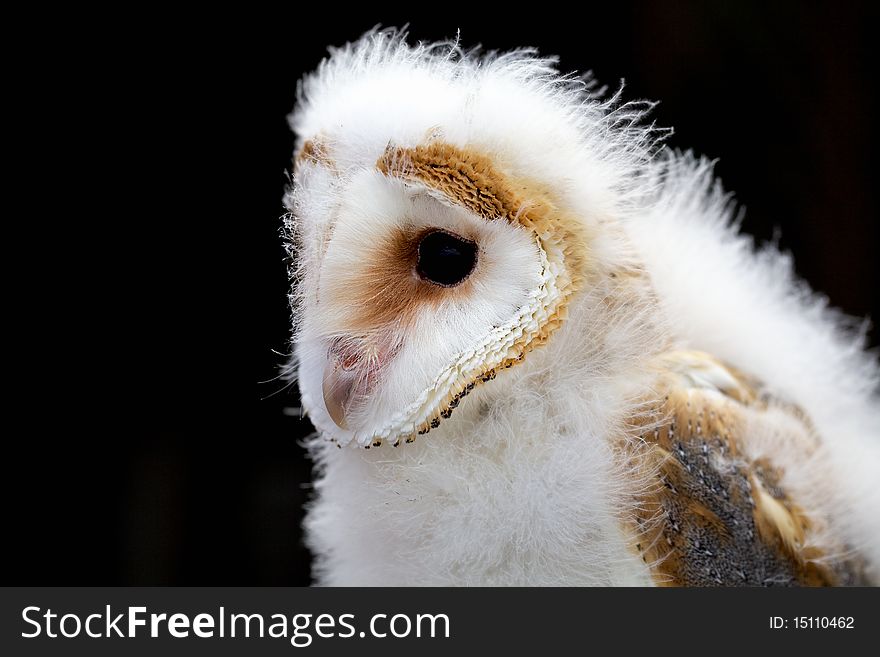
(10, 1, 880, 585)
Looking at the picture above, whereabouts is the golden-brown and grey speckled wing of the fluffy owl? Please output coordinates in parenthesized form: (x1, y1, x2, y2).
(631, 351, 864, 586)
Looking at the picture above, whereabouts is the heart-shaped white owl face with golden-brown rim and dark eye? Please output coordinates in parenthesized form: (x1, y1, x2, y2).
(289, 139, 585, 447)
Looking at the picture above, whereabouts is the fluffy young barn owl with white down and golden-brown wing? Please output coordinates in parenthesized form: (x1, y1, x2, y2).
(285, 31, 880, 586)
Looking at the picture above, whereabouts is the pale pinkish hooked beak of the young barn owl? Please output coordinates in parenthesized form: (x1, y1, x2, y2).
(322, 336, 400, 429)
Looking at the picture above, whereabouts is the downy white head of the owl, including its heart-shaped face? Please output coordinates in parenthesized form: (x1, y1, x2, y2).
(285, 31, 653, 447)
